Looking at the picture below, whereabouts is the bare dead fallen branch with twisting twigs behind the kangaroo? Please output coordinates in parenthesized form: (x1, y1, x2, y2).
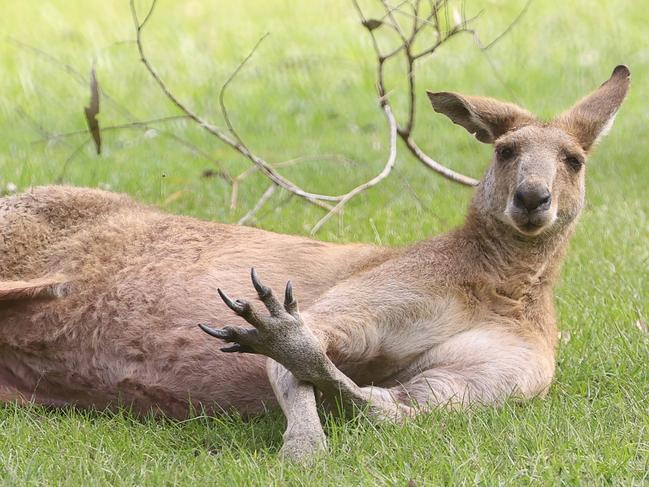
(12, 0, 531, 234)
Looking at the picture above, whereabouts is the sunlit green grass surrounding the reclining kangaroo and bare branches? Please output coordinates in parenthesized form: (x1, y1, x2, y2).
(0, 0, 649, 485)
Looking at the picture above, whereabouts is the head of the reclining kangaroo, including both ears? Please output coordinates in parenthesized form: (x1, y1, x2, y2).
(428, 66, 630, 237)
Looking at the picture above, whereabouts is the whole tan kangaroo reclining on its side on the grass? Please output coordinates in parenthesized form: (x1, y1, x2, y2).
(0, 66, 630, 458)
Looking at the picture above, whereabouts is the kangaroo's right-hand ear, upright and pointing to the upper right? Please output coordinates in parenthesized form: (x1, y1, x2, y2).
(554, 65, 631, 152)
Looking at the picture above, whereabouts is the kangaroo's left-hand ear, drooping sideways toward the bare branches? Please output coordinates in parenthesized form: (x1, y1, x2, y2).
(427, 91, 534, 144)
